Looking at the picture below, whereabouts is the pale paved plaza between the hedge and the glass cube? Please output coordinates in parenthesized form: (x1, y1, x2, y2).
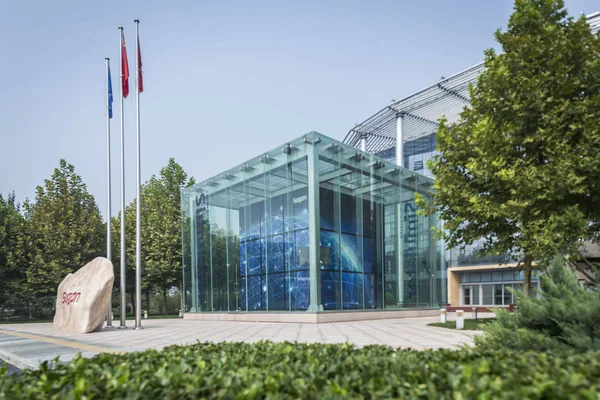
(0, 317, 486, 368)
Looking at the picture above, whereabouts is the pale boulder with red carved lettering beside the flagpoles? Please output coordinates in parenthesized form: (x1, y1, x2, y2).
(53, 257, 115, 333)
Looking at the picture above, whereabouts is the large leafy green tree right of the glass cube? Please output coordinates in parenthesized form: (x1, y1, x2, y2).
(419, 0, 600, 293)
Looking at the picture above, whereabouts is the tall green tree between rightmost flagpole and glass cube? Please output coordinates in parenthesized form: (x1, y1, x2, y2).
(142, 158, 194, 313)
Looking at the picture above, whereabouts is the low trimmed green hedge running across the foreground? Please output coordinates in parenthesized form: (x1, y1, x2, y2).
(0, 342, 600, 399)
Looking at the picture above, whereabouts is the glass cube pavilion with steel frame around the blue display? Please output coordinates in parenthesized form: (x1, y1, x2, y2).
(181, 132, 446, 313)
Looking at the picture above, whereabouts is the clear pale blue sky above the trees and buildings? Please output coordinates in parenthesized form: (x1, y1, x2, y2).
(0, 0, 600, 217)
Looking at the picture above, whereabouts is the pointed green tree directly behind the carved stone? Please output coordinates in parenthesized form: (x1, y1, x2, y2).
(24, 159, 106, 297)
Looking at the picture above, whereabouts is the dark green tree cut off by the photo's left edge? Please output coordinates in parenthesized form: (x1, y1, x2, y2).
(0, 192, 27, 314)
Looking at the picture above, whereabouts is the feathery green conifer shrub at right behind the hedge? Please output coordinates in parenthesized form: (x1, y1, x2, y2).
(475, 257, 600, 353)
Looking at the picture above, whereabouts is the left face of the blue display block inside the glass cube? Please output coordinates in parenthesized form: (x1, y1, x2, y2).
(239, 188, 310, 310)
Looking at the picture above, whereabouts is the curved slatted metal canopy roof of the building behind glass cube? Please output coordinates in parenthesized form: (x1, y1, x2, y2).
(344, 12, 600, 153)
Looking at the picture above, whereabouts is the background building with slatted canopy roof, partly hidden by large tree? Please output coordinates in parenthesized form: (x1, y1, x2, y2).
(344, 12, 600, 307)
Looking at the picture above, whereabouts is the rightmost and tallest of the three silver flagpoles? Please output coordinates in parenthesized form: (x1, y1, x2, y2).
(135, 19, 142, 329)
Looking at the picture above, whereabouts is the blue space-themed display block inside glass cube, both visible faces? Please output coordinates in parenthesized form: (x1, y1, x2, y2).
(240, 185, 376, 310)
